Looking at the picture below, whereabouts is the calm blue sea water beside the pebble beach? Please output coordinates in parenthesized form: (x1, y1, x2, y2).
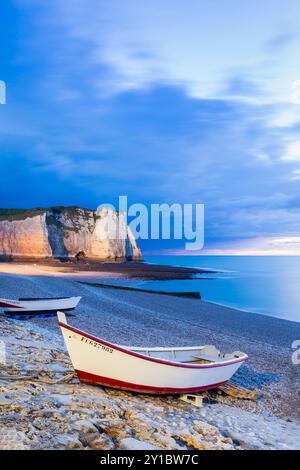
(138, 256, 300, 322)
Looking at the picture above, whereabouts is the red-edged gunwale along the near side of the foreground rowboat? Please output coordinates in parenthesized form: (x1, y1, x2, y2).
(58, 321, 248, 369)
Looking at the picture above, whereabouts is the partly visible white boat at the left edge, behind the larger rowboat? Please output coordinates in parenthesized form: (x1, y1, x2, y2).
(0, 297, 81, 316)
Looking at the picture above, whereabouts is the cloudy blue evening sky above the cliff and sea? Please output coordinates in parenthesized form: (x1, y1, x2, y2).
(0, 0, 300, 254)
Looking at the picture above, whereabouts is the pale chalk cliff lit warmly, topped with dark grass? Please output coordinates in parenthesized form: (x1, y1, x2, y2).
(0, 207, 141, 260)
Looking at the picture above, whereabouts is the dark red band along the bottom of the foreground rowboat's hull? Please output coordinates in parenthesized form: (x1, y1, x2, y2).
(75, 369, 227, 394)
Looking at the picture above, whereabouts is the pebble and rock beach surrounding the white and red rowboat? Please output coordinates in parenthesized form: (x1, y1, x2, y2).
(0, 263, 300, 450)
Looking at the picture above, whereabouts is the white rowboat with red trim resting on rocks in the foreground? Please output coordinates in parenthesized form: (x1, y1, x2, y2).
(57, 312, 248, 394)
